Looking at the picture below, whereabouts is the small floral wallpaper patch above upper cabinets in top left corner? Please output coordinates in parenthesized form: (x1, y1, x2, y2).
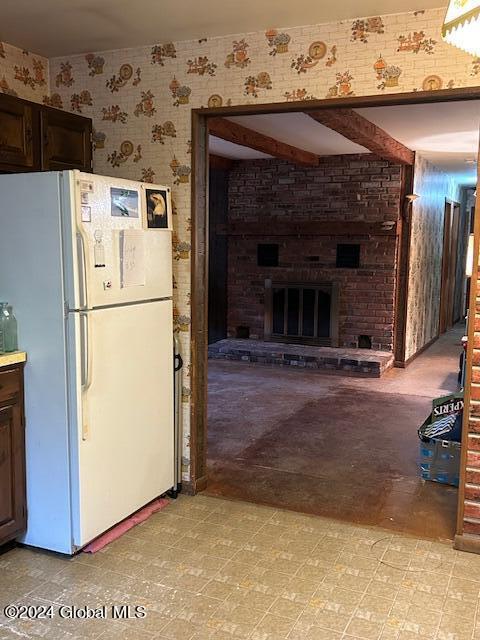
(0, 42, 50, 102)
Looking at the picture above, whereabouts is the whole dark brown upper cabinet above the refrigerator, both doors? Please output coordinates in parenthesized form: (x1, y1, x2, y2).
(0, 94, 92, 173)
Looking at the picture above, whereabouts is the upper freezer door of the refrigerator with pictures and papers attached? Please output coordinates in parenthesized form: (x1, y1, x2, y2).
(64, 171, 173, 309)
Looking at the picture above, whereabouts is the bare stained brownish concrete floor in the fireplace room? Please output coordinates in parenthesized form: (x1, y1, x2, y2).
(207, 325, 464, 540)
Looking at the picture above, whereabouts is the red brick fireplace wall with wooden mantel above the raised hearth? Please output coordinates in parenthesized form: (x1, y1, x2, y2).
(219, 154, 401, 351)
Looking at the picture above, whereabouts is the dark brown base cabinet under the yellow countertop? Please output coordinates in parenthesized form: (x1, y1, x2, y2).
(0, 364, 27, 545)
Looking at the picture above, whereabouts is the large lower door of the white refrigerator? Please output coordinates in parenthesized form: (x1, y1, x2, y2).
(70, 301, 174, 547)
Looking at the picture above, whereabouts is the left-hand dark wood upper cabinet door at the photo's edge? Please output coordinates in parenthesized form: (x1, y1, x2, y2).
(0, 95, 36, 171)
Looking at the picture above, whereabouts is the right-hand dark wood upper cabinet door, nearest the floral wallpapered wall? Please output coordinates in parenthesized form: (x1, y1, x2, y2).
(42, 109, 92, 171)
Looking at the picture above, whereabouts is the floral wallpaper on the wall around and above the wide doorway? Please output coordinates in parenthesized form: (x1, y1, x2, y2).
(6, 9, 480, 478)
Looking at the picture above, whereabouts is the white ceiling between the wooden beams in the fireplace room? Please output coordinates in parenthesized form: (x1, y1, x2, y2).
(210, 100, 480, 184)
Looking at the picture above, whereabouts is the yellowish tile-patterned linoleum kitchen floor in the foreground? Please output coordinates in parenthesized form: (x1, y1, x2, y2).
(0, 495, 480, 640)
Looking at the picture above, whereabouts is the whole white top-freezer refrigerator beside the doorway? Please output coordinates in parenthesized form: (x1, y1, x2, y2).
(0, 171, 174, 554)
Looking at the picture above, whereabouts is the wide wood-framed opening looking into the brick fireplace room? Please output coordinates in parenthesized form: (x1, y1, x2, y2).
(192, 90, 478, 538)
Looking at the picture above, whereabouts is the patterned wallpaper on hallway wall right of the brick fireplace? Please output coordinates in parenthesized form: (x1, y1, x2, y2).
(406, 153, 460, 358)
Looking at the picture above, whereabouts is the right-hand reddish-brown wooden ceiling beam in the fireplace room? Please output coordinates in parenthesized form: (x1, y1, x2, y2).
(305, 109, 415, 165)
